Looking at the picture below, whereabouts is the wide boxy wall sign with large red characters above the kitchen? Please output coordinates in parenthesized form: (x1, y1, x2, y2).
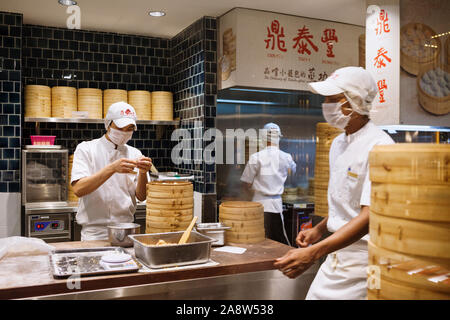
(219, 8, 364, 90)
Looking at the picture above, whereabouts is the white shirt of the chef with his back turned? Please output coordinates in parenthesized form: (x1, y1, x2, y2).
(241, 146, 297, 213)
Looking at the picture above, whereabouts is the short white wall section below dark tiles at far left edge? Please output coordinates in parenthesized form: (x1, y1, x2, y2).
(0, 192, 21, 238)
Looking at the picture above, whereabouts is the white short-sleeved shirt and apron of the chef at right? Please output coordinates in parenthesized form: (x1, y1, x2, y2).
(306, 121, 394, 300)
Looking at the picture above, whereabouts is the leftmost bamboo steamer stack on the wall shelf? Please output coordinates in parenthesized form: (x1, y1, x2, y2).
(24, 85, 52, 118)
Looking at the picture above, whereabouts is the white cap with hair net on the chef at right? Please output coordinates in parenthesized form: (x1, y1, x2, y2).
(309, 67, 378, 115)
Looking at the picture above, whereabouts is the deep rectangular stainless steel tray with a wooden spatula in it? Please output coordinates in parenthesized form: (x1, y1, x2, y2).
(128, 231, 216, 269)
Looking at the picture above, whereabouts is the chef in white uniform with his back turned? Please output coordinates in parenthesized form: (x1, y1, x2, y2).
(241, 123, 297, 245)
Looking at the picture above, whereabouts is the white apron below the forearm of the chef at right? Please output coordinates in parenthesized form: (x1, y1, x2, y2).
(306, 240, 369, 300)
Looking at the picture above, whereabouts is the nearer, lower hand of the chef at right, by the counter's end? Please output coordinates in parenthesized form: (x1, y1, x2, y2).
(274, 247, 315, 279)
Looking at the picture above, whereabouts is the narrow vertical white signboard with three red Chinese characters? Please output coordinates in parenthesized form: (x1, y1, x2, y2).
(366, 0, 400, 125)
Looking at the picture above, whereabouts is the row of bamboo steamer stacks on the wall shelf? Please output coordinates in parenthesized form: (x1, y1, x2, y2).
(25, 85, 173, 121)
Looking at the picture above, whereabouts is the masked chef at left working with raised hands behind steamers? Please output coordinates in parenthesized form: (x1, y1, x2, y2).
(71, 102, 152, 241)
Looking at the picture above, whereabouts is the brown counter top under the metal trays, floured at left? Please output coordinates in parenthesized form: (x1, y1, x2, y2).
(0, 239, 291, 299)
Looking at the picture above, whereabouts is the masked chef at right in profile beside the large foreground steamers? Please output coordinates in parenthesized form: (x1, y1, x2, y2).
(275, 67, 394, 300)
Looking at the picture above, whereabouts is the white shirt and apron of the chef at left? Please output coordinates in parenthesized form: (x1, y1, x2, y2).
(70, 136, 142, 241)
